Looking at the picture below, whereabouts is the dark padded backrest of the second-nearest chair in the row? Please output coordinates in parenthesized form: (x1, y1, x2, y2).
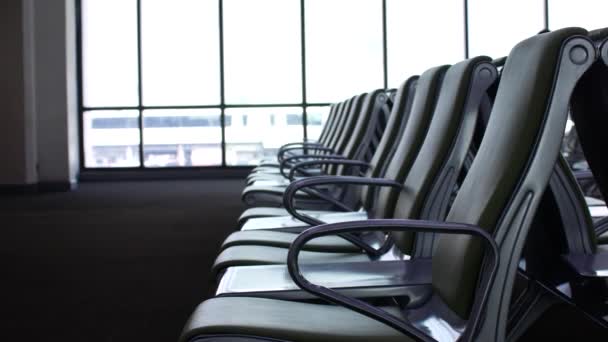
(393, 56, 498, 254)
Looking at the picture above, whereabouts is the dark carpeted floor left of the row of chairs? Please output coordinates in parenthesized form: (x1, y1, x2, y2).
(0, 180, 244, 342)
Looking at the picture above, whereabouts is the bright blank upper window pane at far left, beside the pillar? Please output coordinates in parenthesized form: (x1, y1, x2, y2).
(82, 0, 138, 107)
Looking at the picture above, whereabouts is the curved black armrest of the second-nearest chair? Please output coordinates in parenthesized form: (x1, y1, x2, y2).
(283, 176, 403, 257)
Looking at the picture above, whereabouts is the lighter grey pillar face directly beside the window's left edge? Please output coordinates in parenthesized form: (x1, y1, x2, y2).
(31, 0, 78, 183)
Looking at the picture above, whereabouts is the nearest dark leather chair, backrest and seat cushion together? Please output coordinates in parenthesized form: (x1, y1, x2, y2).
(181, 29, 594, 341)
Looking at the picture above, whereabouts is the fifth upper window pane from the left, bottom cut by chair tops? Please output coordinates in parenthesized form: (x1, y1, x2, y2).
(386, 0, 465, 88)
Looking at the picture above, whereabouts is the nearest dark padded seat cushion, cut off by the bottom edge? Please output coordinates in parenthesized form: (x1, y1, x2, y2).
(180, 297, 410, 342)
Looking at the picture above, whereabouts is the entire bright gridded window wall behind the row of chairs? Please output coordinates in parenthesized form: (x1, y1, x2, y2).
(82, 0, 564, 168)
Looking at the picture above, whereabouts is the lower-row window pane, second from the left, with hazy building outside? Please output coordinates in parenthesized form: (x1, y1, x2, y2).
(143, 109, 223, 167)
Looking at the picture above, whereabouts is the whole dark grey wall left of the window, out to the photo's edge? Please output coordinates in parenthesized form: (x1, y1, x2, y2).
(0, 0, 79, 185)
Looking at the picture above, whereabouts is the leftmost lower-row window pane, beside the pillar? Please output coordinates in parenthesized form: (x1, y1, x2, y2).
(82, 110, 139, 167)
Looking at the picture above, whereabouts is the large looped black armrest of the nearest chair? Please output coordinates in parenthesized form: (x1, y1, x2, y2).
(287, 219, 498, 341)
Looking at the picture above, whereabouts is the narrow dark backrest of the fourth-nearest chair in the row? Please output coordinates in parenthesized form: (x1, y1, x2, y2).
(359, 76, 418, 208)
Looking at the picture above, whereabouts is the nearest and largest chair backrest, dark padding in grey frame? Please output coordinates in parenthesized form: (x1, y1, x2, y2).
(432, 28, 595, 341)
